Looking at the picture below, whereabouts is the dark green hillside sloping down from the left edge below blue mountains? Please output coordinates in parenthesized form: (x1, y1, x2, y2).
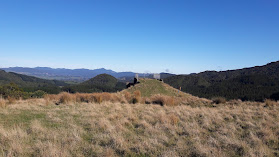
(0, 70, 67, 93)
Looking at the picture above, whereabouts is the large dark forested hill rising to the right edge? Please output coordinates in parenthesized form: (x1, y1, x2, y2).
(164, 61, 279, 101)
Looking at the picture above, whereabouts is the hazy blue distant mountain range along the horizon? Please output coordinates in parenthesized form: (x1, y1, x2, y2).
(1, 67, 173, 82)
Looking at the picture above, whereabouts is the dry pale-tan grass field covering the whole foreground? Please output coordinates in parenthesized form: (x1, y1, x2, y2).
(0, 99, 279, 157)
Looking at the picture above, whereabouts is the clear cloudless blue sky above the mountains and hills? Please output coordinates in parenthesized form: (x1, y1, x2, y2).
(0, 0, 279, 74)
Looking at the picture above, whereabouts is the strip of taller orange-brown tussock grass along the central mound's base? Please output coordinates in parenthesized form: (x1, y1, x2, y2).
(44, 90, 208, 106)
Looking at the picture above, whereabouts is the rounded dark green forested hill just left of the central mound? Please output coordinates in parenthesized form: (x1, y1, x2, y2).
(63, 74, 126, 93)
